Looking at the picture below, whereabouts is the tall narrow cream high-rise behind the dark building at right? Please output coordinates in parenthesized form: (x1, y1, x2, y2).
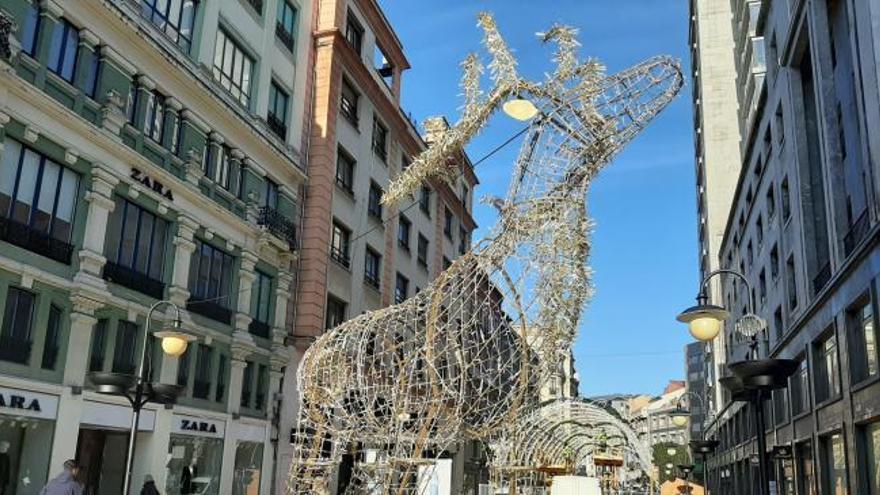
(688, 0, 742, 418)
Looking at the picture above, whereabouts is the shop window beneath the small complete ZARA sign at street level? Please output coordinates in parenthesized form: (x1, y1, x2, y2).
(165, 414, 226, 495)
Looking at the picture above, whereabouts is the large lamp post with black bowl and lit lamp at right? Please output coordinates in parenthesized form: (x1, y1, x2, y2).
(678, 269, 797, 495)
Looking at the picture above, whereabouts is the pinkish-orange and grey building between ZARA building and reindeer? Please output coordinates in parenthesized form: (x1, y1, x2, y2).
(279, 0, 477, 491)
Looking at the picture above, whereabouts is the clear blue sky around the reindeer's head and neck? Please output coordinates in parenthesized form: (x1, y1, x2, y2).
(380, 0, 698, 395)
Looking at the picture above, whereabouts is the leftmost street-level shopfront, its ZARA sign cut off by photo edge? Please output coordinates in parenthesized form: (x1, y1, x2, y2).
(0, 387, 58, 495)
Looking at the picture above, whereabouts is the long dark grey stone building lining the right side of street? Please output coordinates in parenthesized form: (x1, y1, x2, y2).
(701, 0, 880, 494)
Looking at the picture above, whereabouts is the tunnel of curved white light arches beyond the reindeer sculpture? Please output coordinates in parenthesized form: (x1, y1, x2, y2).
(491, 398, 653, 477)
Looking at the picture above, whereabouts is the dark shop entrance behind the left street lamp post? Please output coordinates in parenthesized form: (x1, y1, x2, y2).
(76, 428, 128, 495)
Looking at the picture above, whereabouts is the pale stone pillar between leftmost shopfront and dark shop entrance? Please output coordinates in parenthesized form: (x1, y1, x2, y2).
(49, 294, 103, 473)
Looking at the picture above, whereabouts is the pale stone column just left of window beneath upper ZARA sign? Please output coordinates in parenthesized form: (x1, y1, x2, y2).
(77, 163, 119, 278)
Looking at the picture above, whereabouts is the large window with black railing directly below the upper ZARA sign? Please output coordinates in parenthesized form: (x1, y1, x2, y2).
(104, 197, 168, 290)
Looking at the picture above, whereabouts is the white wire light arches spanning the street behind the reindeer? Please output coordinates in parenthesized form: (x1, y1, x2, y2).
(490, 398, 653, 494)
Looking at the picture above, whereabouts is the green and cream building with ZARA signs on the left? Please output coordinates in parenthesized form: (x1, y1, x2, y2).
(0, 0, 313, 494)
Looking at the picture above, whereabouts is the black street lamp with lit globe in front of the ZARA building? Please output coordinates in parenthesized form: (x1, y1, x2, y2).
(89, 300, 195, 494)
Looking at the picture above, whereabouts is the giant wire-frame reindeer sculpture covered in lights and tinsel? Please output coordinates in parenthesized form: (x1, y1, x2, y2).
(288, 14, 682, 494)
